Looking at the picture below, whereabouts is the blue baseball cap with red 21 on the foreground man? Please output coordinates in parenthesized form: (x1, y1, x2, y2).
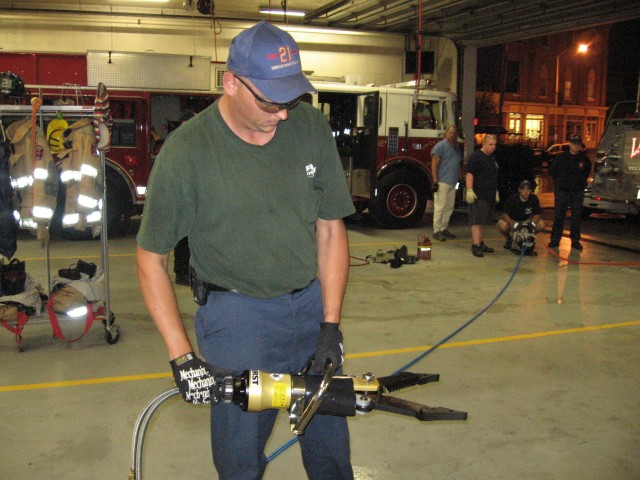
(227, 21, 316, 103)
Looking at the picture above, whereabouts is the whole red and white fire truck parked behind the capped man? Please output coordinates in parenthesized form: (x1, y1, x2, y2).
(0, 52, 461, 231)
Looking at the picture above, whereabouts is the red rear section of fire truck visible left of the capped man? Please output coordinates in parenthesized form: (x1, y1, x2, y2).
(0, 52, 219, 232)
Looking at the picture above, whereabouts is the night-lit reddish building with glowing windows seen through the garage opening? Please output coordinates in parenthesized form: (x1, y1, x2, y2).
(476, 25, 610, 148)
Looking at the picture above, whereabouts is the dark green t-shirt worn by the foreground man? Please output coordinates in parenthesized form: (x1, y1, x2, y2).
(137, 102, 355, 298)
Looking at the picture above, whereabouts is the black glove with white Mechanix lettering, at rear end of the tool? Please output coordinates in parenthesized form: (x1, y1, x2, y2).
(169, 352, 233, 405)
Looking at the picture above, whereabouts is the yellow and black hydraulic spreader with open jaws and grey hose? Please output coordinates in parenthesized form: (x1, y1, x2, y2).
(129, 360, 467, 480)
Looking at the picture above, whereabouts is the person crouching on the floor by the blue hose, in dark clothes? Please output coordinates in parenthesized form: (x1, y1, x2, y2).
(498, 180, 545, 250)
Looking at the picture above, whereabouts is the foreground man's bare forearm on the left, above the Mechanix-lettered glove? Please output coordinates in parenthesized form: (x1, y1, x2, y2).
(136, 247, 193, 360)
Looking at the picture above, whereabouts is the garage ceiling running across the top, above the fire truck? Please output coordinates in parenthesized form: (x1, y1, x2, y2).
(0, 0, 640, 47)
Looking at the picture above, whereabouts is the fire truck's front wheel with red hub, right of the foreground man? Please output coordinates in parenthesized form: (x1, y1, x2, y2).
(371, 170, 427, 228)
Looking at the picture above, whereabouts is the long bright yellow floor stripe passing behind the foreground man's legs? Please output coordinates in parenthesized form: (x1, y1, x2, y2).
(0, 320, 640, 392)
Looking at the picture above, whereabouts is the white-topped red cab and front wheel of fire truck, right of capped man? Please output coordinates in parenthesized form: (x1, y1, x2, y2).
(313, 82, 462, 228)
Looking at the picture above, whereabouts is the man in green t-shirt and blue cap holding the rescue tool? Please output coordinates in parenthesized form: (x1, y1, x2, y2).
(137, 22, 355, 480)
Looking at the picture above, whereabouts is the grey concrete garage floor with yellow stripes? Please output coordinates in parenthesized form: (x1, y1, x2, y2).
(0, 213, 640, 480)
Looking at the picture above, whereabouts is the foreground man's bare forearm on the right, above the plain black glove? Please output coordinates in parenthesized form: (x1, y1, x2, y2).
(316, 220, 349, 323)
